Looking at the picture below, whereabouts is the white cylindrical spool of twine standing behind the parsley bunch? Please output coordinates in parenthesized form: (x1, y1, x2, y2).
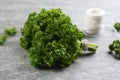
(84, 8, 105, 34)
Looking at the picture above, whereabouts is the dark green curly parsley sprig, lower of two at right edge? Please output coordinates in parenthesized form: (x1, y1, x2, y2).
(109, 40, 120, 58)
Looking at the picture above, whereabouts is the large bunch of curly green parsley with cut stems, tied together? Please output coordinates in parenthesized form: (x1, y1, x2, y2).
(20, 8, 98, 68)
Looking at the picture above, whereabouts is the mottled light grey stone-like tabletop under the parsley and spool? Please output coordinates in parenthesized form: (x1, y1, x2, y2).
(0, 0, 120, 80)
